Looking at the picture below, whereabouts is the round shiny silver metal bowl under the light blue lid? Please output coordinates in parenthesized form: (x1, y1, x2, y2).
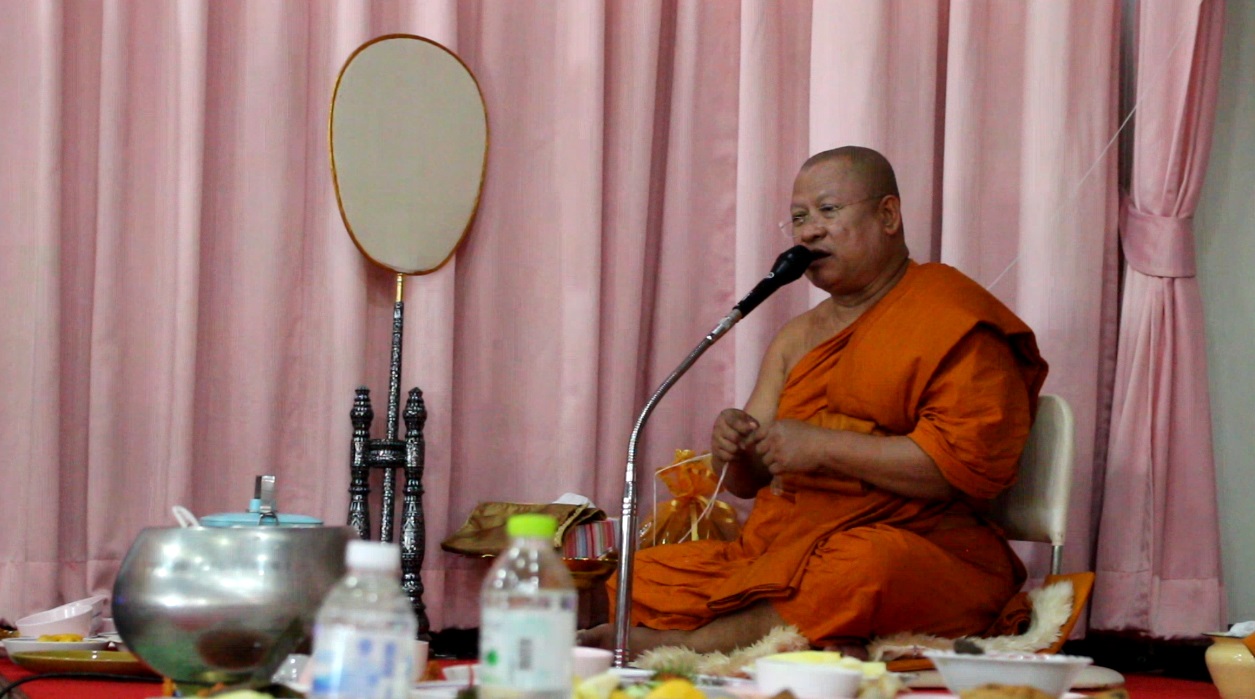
(113, 527, 356, 686)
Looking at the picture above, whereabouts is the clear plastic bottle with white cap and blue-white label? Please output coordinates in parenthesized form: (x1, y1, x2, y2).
(306, 540, 418, 699)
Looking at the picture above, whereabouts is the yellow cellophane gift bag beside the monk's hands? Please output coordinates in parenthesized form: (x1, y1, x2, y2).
(640, 449, 740, 548)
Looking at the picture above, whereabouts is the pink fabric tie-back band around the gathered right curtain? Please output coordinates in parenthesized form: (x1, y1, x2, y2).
(1119, 200, 1196, 277)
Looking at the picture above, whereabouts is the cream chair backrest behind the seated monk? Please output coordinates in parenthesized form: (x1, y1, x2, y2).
(991, 394, 1074, 575)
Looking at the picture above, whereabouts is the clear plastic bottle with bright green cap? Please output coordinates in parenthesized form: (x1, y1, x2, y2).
(478, 515, 579, 699)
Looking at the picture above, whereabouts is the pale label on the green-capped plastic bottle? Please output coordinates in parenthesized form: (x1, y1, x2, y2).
(479, 591, 576, 694)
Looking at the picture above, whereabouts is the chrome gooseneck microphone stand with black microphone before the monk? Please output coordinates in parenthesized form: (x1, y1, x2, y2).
(614, 245, 816, 668)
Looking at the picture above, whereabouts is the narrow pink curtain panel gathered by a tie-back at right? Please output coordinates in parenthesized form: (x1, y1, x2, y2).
(1091, 0, 1226, 638)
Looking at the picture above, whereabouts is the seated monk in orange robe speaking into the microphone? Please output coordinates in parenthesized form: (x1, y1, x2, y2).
(581, 147, 1047, 655)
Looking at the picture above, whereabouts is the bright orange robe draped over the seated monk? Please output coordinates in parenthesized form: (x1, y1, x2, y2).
(610, 262, 1047, 645)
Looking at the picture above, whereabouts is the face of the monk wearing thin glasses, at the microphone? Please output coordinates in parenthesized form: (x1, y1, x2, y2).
(789, 161, 905, 296)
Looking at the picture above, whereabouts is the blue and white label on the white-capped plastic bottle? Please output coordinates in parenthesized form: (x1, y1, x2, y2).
(309, 625, 415, 699)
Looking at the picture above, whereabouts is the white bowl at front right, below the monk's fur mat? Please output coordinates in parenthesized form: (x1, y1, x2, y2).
(924, 650, 1093, 698)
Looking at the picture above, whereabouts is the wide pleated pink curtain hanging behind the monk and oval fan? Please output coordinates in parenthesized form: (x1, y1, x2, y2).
(0, 0, 1184, 629)
